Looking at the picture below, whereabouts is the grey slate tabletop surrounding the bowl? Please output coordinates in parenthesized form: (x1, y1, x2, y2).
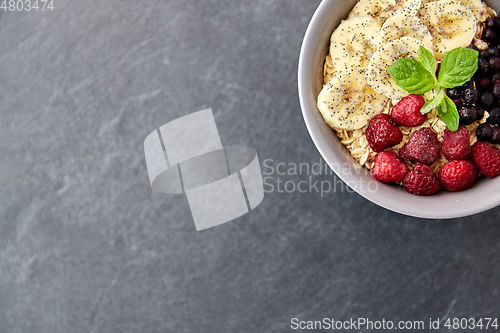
(0, 0, 500, 333)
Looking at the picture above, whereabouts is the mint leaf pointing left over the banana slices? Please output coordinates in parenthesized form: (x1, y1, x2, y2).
(387, 58, 436, 95)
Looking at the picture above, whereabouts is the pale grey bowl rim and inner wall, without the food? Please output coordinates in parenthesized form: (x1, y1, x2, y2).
(297, 0, 500, 219)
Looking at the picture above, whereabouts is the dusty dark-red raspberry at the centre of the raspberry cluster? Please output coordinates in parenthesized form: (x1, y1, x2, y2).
(399, 128, 441, 165)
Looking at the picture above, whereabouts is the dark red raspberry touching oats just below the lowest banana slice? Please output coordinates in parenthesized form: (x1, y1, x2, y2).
(366, 113, 403, 152)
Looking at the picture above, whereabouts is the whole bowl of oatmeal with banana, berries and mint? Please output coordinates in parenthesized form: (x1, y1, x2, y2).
(298, 0, 500, 219)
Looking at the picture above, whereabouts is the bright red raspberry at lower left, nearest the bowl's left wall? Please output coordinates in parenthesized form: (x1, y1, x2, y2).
(372, 151, 410, 183)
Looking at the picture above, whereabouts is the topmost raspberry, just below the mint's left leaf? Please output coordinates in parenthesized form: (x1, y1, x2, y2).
(391, 95, 427, 127)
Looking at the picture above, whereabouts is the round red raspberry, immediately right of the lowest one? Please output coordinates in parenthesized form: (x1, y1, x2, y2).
(439, 160, 478, 192)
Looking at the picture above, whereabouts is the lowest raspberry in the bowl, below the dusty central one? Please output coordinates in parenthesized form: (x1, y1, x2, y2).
(403, 163, 439, 195)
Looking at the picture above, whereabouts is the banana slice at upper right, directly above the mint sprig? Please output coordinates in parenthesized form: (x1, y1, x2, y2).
(419, 0, 477, 60)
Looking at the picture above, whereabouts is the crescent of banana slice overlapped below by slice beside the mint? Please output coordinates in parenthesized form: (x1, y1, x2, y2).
(377, 14, 433, 50)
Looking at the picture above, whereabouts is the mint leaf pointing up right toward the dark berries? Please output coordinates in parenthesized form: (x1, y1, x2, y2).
(438, 47, 479, 88)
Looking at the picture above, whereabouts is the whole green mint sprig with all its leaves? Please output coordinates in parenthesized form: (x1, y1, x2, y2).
(387, 46, 479, 131)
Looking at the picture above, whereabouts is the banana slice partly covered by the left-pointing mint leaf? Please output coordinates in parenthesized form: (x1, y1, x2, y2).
(365, 37, 432, 99)
